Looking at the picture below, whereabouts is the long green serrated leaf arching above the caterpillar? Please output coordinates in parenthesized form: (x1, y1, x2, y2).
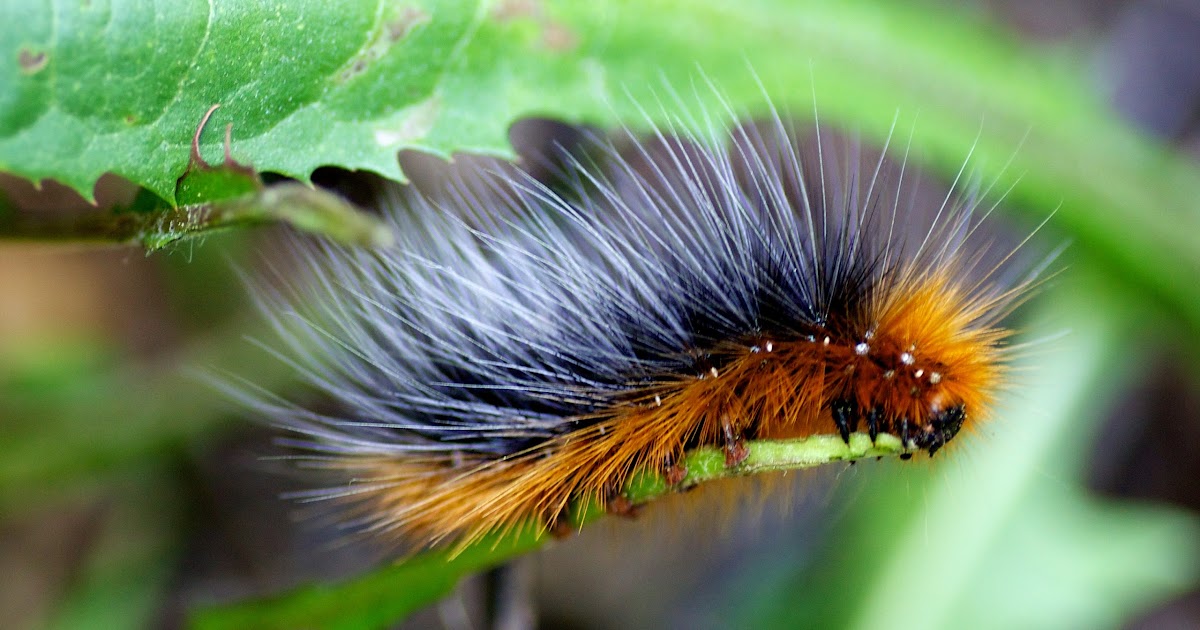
(0, 0, 1200, 329)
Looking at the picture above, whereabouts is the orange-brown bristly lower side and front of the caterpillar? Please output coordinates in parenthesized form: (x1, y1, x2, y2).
(341, 265, 1008, 544)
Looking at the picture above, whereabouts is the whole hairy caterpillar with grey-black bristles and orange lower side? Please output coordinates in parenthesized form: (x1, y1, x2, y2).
(243, 103, 1030, 544)
